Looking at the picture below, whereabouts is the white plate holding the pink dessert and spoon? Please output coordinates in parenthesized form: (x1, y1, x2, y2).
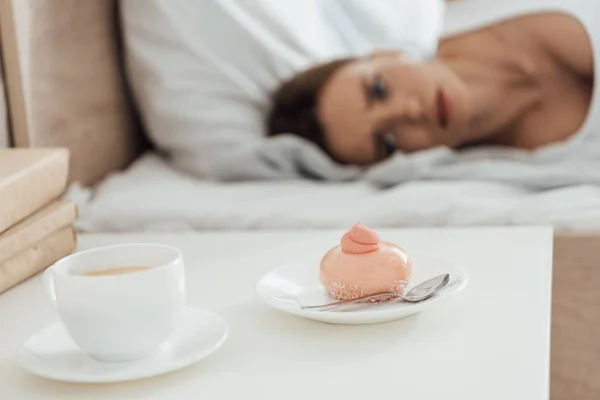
(255, 254, 467, 324)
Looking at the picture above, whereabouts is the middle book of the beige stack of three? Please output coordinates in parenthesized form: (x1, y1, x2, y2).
(0, 200, 77, 263)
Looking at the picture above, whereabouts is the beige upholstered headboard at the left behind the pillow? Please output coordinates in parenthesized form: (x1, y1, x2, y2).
(0, 0, 143, 185)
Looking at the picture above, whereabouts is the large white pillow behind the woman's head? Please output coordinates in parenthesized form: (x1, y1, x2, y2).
(121, 0, 444, 179)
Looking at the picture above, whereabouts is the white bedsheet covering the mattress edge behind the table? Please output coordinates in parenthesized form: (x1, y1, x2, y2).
(68, 154, 600, 231)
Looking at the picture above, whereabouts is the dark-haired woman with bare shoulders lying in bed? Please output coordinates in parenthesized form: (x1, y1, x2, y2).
(269, 0, 600, 165)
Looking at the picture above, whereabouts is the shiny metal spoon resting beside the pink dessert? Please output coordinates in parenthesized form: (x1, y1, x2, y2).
(300, 274, 450, 311)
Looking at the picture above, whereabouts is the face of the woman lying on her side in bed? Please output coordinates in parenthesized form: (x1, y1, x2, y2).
(317, 52, 469, 165)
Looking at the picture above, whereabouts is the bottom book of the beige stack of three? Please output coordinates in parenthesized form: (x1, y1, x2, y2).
(0, 226, 77, 293)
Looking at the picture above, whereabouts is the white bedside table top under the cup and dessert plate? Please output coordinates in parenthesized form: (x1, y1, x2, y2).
(0, 228, 552, 400)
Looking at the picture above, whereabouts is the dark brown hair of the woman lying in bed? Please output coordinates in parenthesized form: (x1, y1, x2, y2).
(267, 58, 354, 154)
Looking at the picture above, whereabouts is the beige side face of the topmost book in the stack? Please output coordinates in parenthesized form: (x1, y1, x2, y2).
(0, 151, 69, 233)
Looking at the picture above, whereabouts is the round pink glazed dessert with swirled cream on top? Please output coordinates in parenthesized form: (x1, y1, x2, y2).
(320, 223, 412, 301)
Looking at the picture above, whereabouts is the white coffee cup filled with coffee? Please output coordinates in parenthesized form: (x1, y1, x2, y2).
(44, 243, 185, 361)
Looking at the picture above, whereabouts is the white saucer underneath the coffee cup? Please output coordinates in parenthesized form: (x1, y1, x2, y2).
(18, 308, 228, 382)
